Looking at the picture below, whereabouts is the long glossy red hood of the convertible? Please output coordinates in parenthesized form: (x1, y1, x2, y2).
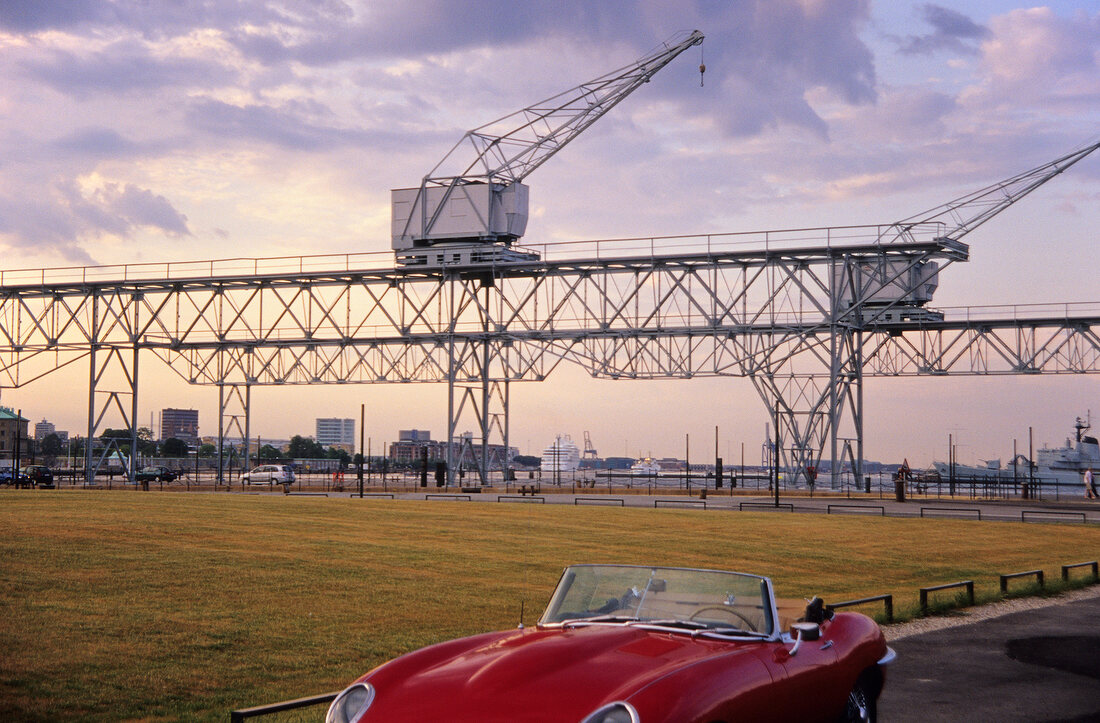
(362, 625, 761, 723)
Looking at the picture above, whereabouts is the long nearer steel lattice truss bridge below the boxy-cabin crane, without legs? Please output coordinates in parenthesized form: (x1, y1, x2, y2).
(0, 227, 965, 386)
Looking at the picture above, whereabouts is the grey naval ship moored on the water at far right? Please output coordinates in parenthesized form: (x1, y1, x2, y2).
(932, 417, 1100, 485)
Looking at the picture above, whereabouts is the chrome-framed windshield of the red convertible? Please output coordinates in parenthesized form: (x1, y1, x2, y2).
(539, 565, 776, 636)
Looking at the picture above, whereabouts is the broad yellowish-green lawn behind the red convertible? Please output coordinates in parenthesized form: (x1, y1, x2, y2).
(0, 491, 1100, 721)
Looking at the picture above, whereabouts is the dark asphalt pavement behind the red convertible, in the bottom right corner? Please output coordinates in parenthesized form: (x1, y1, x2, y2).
(879, 598, 1100, 723)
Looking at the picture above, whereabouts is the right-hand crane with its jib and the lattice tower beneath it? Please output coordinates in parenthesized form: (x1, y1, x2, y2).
(741, 137, 1100, 482)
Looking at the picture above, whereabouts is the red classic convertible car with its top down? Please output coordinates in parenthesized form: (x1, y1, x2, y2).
(326, 565, 894, 723)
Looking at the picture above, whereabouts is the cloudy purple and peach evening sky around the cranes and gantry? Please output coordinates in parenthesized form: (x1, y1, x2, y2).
(0, 0, 1100, 465)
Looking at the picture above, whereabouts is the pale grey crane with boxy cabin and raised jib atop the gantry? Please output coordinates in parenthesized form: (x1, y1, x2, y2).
(391, 30, 703, 266)
